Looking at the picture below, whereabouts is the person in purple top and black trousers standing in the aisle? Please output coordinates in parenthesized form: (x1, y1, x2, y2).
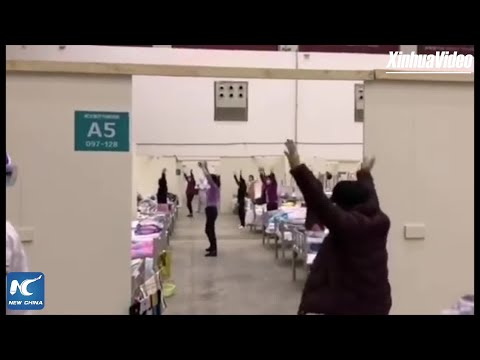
(198, 161, 220, 257)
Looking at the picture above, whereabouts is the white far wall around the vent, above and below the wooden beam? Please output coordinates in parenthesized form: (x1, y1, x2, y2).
(7, 45, 394, 160)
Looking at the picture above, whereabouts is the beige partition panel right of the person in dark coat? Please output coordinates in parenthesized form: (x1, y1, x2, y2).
(364, 81, 474, 314)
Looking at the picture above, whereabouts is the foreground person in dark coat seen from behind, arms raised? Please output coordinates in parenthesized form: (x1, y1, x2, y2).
(285, 140, 392, 315)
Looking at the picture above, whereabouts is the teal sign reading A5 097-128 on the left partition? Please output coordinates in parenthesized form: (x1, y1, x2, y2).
(75, 111, 130, 152)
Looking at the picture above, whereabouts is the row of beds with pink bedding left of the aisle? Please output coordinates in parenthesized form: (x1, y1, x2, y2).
(129, 199, 178, 315)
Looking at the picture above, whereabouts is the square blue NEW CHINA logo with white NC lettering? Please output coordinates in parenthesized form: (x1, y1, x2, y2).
(7, 272, 45, 310)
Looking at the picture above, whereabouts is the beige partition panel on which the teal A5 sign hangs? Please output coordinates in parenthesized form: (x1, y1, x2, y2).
(6, 73, 133, 315)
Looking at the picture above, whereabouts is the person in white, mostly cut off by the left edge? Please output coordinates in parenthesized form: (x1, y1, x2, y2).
(5, 154, 30, 315)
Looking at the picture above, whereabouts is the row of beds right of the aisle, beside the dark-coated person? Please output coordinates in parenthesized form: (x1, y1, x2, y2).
(247, 193, 330, 281)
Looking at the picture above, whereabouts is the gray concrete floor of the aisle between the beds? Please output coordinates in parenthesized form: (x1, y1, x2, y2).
(165, 208, 305, 315)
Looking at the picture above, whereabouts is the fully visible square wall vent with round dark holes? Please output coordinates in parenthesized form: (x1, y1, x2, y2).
(214, 81, 248, 121)
